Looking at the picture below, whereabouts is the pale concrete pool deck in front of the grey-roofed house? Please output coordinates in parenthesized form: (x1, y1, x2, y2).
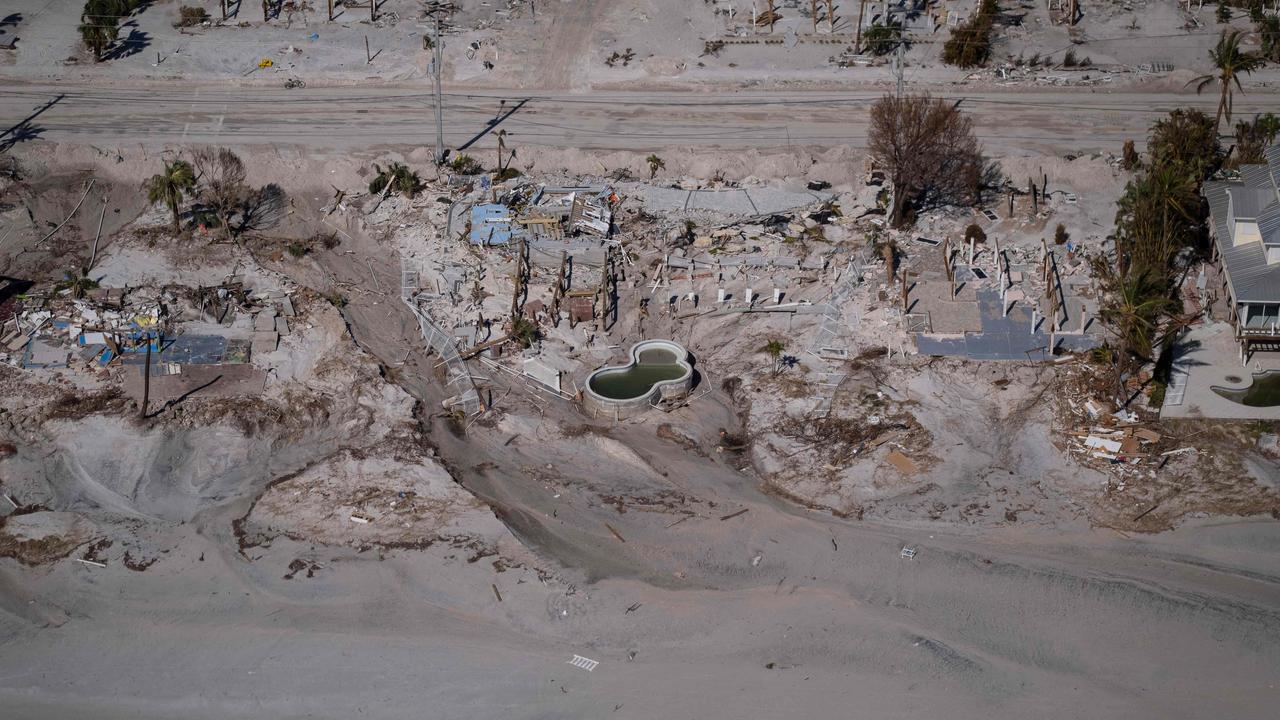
(1160, 323, 1280, 420)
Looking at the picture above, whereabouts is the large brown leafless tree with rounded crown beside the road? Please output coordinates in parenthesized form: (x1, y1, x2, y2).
(868, 94, 984, 228)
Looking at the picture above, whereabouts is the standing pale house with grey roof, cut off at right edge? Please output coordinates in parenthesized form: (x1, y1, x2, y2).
(1204, 145, 1280, 360)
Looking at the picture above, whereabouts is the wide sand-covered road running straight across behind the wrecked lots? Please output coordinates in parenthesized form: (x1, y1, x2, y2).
(0, 85, 1276, 154)
